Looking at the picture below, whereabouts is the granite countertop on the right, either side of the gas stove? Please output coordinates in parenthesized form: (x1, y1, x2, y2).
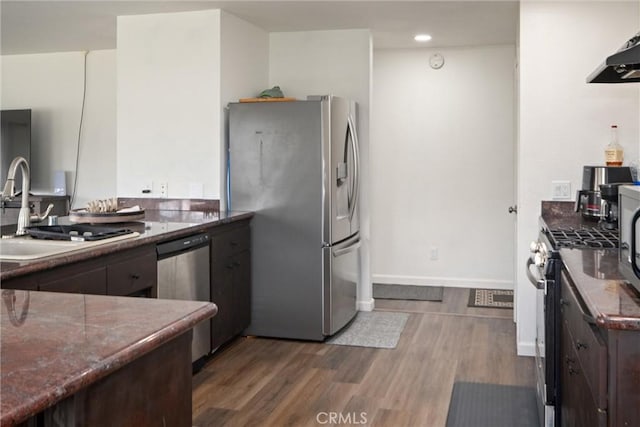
(541, 202, 640, 331)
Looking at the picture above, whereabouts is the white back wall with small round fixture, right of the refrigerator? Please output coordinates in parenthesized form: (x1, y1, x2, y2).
(371, 45, 516, 289)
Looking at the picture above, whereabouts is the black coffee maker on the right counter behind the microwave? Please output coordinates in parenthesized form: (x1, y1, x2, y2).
(576, 166, 633, 228)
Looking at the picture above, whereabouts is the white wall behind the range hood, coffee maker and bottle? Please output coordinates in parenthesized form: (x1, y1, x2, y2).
(516, 2, 640, 354)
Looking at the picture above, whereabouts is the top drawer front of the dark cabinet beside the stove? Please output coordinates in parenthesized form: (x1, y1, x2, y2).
(560, 276, 607, 410)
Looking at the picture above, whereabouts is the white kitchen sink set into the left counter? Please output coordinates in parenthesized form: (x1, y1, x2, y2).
(0, 232, 140, 261)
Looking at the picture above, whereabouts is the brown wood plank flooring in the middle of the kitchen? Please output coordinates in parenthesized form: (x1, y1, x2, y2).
(193, 288, 535, 427)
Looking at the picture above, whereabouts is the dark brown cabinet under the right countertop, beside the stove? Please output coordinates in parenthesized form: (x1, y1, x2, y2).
(560, 270, 640, 427)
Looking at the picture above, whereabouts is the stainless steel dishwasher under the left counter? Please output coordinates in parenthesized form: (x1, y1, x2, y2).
(156, 234, 211, 371)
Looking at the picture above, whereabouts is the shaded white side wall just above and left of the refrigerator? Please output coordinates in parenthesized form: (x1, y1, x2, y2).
(220, 11, 269, 210)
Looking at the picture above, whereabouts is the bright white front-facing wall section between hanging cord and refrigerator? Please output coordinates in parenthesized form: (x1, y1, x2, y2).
(117, 10, 222, 199)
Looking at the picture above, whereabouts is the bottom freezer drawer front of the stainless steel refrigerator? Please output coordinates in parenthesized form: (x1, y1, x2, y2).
(323, 235, 360, 335)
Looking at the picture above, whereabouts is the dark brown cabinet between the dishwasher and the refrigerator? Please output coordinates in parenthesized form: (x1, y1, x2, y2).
(211, 221, 251, 349)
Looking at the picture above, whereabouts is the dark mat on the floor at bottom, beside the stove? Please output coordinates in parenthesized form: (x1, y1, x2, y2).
(446, 382, 540, 427)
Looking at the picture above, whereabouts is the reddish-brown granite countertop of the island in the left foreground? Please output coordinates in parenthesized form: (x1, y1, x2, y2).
(0, 290, 217, 426)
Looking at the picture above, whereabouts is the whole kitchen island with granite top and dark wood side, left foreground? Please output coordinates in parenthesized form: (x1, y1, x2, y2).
(0, 290, 217, 426)
